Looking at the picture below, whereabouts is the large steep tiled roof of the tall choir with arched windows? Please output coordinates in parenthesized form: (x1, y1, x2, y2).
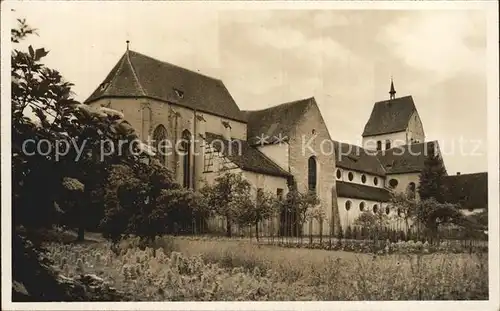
(85, 50, 245, 122)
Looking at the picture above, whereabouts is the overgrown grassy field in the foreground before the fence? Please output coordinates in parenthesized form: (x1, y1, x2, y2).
(43, 237, 488, 300)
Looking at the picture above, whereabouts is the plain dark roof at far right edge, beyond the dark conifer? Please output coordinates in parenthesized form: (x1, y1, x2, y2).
(444, 172, 488, 209)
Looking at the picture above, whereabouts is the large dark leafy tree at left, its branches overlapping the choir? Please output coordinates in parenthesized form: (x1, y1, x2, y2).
(11, 20, 152, 239)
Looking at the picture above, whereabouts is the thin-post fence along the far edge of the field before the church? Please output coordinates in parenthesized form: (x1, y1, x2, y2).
(173, 214, 488, 248)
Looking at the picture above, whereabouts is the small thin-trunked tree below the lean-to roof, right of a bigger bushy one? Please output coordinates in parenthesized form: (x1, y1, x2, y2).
(238, 189, 278, 241)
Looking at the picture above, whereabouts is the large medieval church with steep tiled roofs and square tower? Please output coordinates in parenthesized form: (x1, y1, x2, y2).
(85, 47, 487, 234)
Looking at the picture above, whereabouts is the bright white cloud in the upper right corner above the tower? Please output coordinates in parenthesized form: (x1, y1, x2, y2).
(377, 11, 486, 80)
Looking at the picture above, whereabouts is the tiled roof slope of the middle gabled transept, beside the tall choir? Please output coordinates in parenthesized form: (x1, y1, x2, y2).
(243, 97, 315, 145)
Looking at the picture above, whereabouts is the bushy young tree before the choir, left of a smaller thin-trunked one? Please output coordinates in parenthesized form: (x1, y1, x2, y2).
(200, 171, 257, 237)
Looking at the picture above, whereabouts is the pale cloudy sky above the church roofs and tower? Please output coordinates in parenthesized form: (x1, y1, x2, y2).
(11, 1, 488, 174)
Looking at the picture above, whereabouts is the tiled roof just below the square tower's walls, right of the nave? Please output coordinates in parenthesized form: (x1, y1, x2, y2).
(377, 141, 439, 174)
